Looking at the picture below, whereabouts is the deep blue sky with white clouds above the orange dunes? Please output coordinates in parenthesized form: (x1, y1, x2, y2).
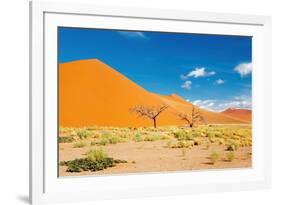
(58, 27, 252, 111)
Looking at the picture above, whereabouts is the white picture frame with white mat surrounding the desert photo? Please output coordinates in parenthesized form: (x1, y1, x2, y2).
(30, 1, 271, 204)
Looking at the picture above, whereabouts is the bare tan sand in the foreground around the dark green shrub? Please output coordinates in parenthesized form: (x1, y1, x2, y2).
(59, 140, 252, 176)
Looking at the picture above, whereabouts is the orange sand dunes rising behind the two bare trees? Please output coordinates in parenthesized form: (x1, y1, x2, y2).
(59, 59, 244, 127)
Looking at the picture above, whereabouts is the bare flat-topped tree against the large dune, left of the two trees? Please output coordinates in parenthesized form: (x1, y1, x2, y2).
(130, 105, 169, 128)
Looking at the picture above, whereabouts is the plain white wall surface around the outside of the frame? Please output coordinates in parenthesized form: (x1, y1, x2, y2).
(0, 0, 281, 205)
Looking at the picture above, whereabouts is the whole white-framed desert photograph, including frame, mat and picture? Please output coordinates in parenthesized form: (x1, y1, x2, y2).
(30, 2, 271, 204)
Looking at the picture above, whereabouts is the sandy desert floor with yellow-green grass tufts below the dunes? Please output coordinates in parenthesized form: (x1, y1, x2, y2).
(59, 124, 252, 176)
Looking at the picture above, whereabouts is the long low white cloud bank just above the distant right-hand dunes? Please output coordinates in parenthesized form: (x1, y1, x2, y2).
(192, 95, 252, 112)
